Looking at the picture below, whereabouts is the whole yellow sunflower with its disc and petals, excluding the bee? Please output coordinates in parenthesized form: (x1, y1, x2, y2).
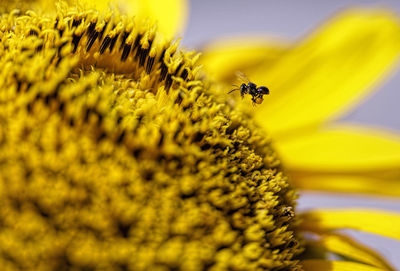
(0, 0, 400, 270)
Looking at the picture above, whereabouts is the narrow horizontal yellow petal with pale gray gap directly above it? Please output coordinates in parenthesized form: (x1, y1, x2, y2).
(301, 209, 400, 239)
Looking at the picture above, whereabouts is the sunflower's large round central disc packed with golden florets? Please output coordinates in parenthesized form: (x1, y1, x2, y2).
(0, 5, 302, 271)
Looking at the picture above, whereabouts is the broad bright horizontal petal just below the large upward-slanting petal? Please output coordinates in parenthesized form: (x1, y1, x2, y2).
(276, 124, 400, 173)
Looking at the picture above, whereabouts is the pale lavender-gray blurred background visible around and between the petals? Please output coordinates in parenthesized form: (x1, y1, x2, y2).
(182, 0, 400, 270)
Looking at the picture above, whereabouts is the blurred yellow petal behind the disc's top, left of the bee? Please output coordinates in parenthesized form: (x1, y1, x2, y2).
(83, 0, 188, 38)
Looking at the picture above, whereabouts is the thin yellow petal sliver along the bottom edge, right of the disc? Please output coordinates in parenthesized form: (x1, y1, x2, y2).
(302, 260, 385, 271)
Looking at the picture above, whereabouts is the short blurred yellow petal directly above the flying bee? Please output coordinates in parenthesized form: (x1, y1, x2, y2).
(200, 36, 289, 83)
